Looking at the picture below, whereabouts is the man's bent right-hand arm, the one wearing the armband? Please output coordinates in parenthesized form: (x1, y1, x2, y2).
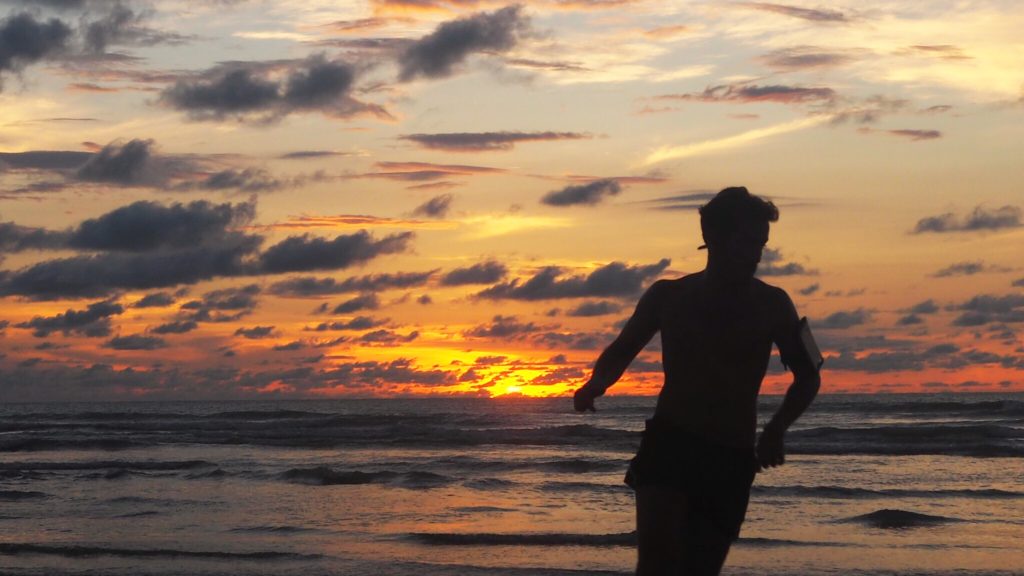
(757, 290, 821, 468)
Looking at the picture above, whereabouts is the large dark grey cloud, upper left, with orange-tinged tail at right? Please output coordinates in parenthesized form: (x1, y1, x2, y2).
(160, 54, 380, 122)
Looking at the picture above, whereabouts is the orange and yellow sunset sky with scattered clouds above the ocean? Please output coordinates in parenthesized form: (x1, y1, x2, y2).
(0, 0, 1024, 402)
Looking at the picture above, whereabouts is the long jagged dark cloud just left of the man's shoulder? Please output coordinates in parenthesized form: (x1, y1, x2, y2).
(477, 258, 672, 300)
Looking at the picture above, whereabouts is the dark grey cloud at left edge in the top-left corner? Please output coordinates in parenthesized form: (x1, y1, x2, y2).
(0, 12, 72, 89)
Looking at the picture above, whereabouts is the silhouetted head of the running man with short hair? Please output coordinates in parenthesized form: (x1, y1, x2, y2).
(700, 187, 778, 277)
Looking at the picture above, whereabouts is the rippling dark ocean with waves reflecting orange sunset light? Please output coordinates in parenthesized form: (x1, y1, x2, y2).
(0, 394, 1024, 576)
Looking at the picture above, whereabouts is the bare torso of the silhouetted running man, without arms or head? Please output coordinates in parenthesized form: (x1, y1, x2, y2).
(654, 273, 782, 447)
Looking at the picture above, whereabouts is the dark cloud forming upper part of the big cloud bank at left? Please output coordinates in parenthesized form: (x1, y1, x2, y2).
(68, 200, 256, 252)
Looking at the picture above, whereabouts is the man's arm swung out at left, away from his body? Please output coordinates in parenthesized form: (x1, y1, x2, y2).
(572, 280, 666, 412)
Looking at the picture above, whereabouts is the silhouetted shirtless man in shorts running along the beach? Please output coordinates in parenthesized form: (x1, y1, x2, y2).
(573, 188, 821, 576)
